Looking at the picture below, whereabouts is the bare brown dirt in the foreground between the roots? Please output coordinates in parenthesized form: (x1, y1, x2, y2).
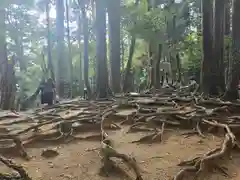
(0, 128, 240, 180)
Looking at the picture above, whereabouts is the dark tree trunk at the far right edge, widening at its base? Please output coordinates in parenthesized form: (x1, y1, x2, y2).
(225, 0, 240, 100)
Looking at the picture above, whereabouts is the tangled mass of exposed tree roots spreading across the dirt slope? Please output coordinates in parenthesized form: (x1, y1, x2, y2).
(0, 88, 240, 180)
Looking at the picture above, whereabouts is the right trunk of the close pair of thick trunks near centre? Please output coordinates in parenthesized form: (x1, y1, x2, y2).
(107, 0, 121, 93)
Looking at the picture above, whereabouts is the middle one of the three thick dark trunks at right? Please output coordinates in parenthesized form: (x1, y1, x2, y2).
(212, 0, 225, 92)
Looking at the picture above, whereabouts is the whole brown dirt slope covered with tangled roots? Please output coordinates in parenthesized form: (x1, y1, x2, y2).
(0, 88, 240, 180)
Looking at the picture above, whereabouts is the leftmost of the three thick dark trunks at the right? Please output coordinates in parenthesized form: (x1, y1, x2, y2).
(201, 0, 215, 95)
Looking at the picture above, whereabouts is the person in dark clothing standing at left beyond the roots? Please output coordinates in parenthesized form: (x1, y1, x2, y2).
(40, 78, 55, 105)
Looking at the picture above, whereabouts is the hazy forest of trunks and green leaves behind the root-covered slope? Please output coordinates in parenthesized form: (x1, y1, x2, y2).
(0, 0, 238, 109)
